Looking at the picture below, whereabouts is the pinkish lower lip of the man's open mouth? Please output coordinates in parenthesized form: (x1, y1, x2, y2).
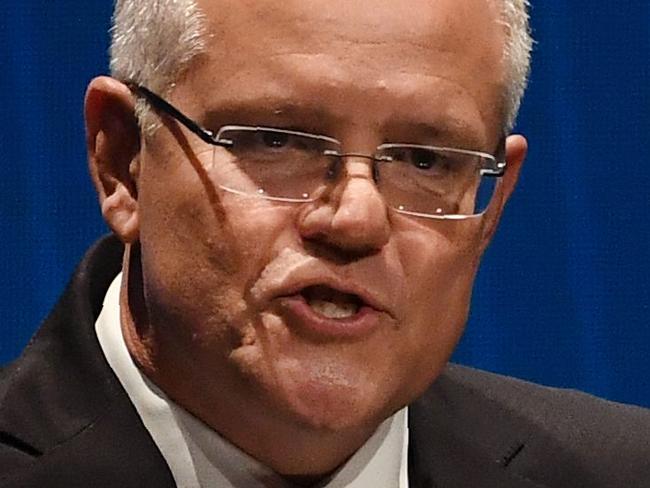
(281, 295, 379, 340)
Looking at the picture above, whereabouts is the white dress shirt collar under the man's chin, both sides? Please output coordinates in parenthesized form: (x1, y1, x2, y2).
(95, 273, 408, 488)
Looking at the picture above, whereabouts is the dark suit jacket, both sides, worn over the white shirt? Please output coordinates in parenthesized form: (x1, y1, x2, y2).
(0, 234, 650, 488)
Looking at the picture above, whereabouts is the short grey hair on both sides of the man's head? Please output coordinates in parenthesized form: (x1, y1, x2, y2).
(110, 0, 533, 133)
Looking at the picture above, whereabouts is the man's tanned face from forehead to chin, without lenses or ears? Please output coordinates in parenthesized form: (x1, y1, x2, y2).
(133, 0, 502, 432)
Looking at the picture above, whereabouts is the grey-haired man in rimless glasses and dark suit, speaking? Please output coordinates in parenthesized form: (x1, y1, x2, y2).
(0, 0, 650, 488)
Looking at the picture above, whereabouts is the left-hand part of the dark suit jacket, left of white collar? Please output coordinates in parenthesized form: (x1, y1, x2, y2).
(0, 237, 173, 488)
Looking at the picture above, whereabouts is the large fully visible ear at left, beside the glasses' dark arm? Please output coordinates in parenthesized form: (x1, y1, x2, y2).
(84, 76, 140, 243)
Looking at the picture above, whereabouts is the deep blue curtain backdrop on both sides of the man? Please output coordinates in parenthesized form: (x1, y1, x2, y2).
(0, 0, 650, 406)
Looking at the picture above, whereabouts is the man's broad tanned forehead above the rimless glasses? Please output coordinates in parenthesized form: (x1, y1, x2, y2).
(180, 0, 503, 143)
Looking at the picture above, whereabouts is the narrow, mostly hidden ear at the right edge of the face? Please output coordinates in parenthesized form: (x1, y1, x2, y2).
(482, 135, 528, 249)
